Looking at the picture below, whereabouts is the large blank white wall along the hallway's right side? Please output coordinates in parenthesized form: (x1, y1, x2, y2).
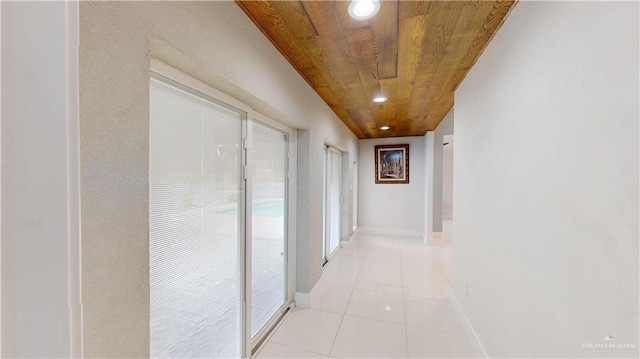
(453, 2, 640, 357)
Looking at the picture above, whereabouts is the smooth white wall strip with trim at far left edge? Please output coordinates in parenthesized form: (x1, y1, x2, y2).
(0, 2, 81, 358)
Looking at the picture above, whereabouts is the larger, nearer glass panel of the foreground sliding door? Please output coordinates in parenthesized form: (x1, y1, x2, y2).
(149, 79, 245, 358)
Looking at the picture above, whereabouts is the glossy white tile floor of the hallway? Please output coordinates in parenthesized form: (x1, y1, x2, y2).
(257, 235, 474, 358)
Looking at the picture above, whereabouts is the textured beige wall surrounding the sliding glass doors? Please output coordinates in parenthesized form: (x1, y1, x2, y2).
(80, 2, 358, 357)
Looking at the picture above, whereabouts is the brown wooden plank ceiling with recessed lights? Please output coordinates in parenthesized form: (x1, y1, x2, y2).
(237, 1, 515, 138)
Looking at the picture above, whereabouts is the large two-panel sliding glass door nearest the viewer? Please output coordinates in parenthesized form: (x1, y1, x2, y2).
(149, 67, 293, 358)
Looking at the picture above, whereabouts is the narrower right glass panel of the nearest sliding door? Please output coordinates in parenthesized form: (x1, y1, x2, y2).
(250, 122, 288, 337)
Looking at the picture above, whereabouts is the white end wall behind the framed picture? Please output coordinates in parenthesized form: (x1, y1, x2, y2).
(358, 137, 425, 236)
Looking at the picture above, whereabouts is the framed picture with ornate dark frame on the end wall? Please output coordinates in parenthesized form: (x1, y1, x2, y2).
(375, 144, 409, 183)
